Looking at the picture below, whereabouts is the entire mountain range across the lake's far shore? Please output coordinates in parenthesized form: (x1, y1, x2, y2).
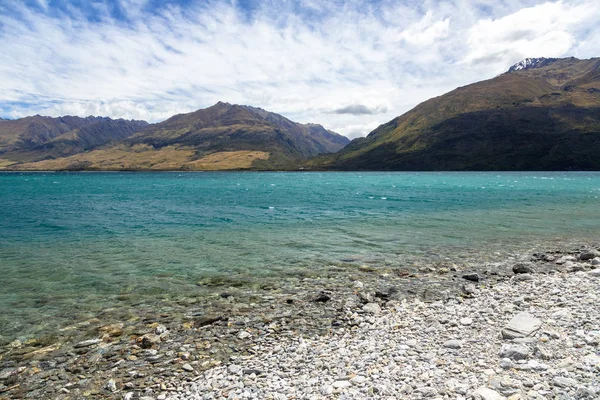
(0, 57, 600, 171)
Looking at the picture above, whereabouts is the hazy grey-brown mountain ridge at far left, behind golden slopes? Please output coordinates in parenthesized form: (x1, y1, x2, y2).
(0, 115, 148, 166)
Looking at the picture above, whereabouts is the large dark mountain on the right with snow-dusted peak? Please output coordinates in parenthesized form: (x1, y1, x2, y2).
(305, 58, 600, 170)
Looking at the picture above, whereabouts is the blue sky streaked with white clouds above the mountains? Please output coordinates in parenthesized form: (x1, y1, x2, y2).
(0, 0, 600, 138)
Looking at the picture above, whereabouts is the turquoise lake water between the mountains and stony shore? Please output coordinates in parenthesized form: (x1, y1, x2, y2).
(0, 172, 600, 339)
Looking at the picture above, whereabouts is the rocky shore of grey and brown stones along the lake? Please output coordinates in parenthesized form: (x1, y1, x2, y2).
(0, 245, 600, 400)
